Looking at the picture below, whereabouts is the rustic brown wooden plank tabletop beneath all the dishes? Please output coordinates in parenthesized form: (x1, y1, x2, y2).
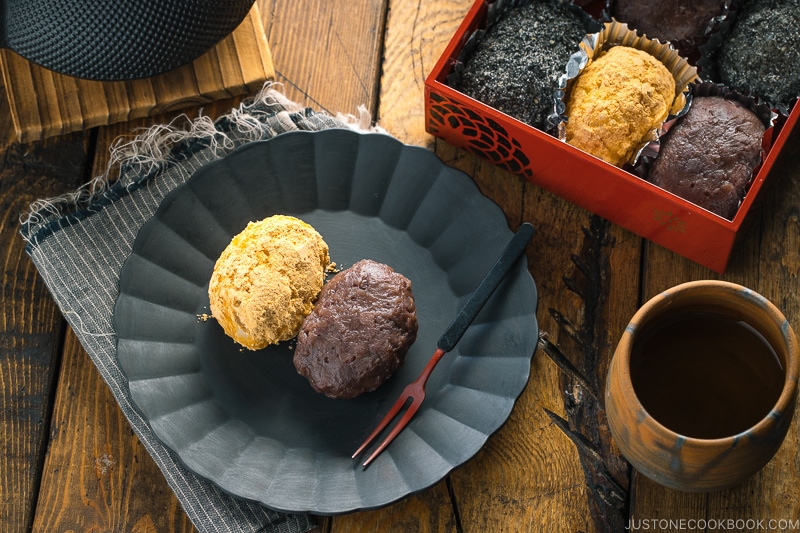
(0, 0, 800, 533)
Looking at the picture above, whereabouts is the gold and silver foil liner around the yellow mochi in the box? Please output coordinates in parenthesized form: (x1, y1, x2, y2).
(549, 20, 699, 167)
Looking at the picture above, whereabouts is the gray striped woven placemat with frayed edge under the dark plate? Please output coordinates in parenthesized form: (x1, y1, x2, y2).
(21, 86, 368, 533)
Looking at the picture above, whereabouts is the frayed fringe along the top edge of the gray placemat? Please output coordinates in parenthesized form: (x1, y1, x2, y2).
(20, 82, 386, 253)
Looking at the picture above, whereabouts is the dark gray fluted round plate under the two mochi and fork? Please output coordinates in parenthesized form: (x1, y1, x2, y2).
(114, 130, 538, 514)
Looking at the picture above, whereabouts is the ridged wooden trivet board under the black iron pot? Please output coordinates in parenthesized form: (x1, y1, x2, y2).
(0, 5, 274, 142)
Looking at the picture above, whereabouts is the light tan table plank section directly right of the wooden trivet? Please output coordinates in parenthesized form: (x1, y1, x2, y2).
(258, 0, 387, 116)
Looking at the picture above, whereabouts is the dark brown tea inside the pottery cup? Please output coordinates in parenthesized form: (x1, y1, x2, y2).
(630, 310, 784, 439)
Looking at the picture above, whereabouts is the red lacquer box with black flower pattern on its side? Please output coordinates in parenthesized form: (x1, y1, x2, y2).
(425, 0, 800, 273)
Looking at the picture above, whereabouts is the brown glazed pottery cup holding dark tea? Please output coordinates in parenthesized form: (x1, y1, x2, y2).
(605, 281, 799, 492)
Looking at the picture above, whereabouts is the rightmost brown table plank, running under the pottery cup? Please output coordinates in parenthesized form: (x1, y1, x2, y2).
(631, 119, 800, 531)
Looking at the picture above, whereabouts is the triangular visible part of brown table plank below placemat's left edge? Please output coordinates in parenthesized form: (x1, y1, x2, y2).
(33, 330, 196, 533)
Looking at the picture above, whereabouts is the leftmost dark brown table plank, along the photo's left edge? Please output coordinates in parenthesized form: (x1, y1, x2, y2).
(0, 88, 88, 532)
